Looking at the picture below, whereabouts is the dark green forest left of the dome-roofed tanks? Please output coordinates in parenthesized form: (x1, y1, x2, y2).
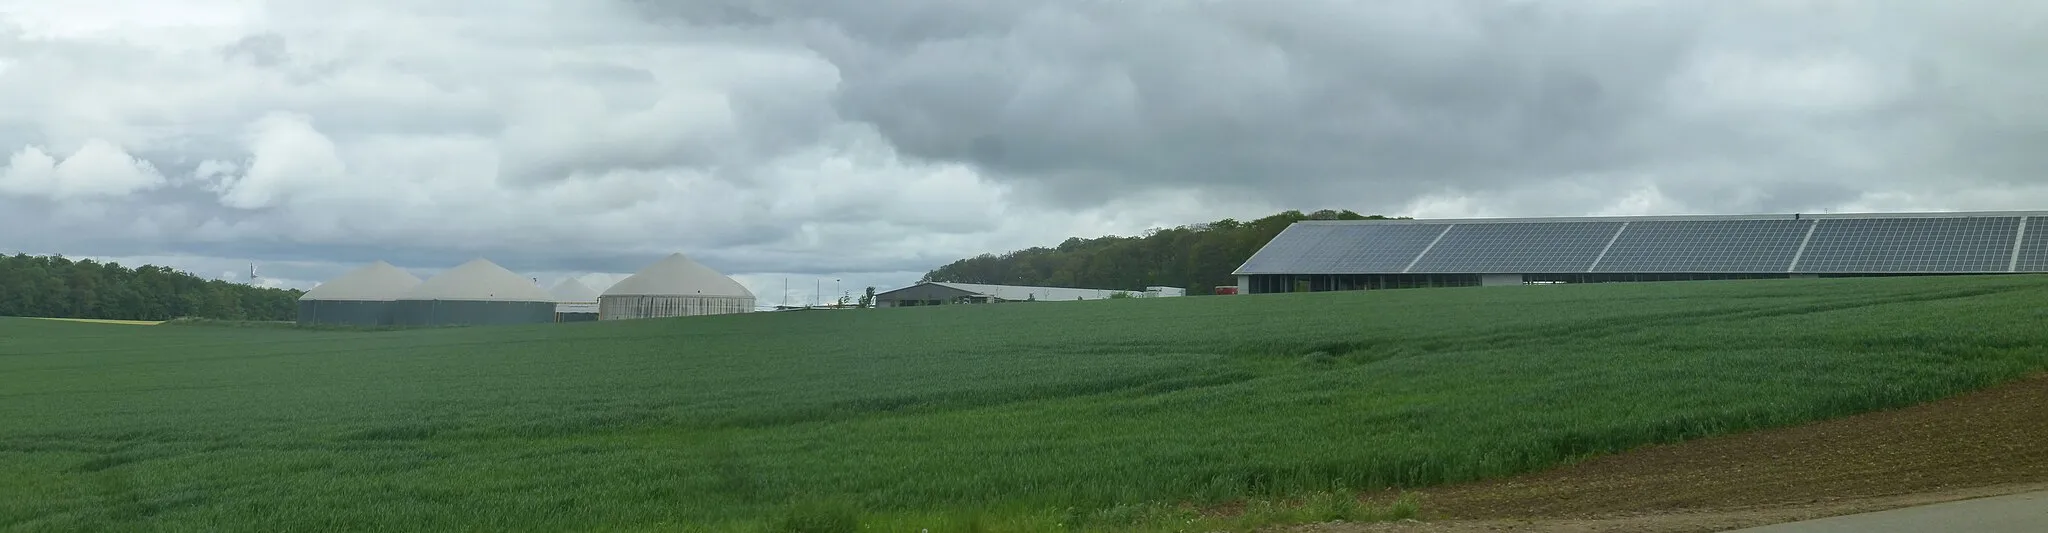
(0, 254, 299, 320)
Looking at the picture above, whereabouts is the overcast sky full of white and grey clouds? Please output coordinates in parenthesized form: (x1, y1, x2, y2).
(0, 0, 2048, 303)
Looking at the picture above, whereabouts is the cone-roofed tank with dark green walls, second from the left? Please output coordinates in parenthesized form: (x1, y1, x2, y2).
(395, 258, 555, 326)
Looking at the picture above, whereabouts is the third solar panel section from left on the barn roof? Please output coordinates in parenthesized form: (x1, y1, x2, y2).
(1593, 219, 1812, 273)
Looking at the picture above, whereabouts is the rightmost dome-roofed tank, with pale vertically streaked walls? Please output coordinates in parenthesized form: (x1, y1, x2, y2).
(598, 254, 754, 320)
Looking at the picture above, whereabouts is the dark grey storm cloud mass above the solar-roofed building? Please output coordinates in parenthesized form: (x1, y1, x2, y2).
(641, 0, 2048, 209)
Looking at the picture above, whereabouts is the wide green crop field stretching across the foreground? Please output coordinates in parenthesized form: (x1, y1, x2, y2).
(0, 277, 2048, 531)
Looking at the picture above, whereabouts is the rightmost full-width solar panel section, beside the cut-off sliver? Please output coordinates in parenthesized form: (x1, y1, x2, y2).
(1794, 217, 2019, 273)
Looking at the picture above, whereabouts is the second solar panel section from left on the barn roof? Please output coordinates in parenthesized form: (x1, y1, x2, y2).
(1409, 221, 1622, 273)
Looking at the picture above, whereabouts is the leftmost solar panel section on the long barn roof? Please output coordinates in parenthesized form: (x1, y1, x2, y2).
(1239, 223, 1444, 275)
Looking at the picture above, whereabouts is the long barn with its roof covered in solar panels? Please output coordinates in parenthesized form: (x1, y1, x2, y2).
(1235, 211, 2048, 293)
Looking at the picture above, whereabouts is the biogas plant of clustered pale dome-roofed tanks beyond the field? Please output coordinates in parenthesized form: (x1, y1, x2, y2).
(299, 254, 754, 326)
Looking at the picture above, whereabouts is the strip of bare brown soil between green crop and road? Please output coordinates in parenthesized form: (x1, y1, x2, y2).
(1298, 375, 2048, 533)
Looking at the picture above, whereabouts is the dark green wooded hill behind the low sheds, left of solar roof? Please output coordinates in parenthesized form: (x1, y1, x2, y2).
(924, 209, 1389, 295)
